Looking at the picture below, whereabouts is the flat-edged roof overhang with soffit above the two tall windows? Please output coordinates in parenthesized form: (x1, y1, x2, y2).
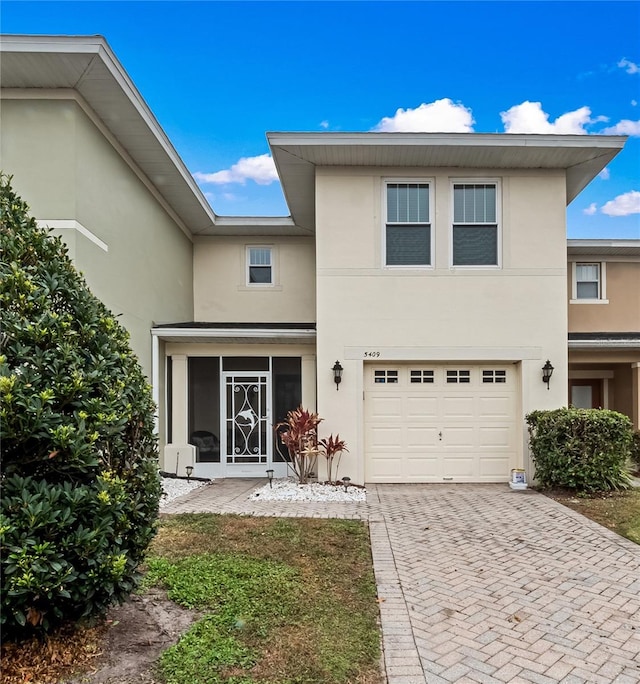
(267, 132, 626, 229)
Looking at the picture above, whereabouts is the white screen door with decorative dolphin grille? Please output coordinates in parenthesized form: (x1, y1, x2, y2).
(221, 371, 273, 477)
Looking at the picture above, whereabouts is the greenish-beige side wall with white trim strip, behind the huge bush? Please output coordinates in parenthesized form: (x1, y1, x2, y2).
(1, 97, 193, 377)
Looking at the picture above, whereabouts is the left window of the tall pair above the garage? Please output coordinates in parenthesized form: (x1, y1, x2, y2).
(385, 183, 431, 266)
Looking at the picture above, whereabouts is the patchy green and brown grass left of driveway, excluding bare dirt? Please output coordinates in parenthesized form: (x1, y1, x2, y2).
(145, 514, 381, 684)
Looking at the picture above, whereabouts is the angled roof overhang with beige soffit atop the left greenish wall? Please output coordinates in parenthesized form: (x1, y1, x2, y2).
(0, 35, 300, 235)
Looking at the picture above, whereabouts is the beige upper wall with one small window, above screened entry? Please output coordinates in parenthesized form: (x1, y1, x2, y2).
(194, 237, 316, 323)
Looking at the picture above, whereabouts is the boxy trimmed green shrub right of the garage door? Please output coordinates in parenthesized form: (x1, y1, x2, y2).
(527, 408, 633, 493)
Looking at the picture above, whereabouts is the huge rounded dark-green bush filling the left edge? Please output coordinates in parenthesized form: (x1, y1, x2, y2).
(0, 174, 161, 639)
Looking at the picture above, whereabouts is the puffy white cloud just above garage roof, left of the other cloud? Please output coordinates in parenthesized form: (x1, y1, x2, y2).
(372, 97, 474, 133)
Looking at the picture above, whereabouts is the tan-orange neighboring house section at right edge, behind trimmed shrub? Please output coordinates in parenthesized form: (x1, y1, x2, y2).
(567, 240, 640, 422)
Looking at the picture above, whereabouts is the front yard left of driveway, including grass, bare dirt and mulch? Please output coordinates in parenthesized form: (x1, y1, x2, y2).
(2, 514, 382, 684)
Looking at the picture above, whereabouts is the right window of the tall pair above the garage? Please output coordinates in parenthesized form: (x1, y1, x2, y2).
(452, 183, 499, 266)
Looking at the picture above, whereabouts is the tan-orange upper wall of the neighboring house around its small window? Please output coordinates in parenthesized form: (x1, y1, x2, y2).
(567, 257, 640, 332)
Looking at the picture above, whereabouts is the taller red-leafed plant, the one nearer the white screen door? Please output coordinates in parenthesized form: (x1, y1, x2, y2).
(274, 406, 322, 484)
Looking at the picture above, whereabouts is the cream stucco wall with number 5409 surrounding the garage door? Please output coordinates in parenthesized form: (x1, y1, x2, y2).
(316, 168, 567, 481)
